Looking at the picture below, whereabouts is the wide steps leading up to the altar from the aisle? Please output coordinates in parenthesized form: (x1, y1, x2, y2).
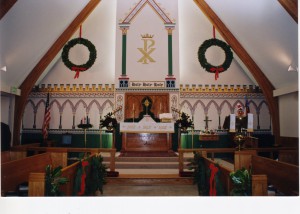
(104, 157, 193, 186)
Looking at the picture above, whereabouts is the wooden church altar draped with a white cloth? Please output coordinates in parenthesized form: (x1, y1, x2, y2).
(120, 115, 174, 152)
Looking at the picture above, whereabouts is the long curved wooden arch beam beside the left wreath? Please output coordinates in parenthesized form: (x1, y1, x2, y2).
(13, 0, 101, 145)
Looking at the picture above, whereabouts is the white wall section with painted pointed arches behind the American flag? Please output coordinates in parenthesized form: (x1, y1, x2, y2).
(23, 97, 114, 129)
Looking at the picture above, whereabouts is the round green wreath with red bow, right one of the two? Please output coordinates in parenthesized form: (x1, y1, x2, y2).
(198, 38, 233, 80)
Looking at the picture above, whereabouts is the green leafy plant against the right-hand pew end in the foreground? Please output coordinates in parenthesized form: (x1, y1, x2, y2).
(229, 167, 252, 196)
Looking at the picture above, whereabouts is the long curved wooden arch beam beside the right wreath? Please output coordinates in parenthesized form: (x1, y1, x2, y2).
(194, 0, 280, 144)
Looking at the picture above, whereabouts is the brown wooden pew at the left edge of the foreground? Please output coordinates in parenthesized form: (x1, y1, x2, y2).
(1, 150, 66, 195)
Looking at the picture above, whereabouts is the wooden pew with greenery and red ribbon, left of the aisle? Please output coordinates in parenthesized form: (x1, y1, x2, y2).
(28, 154, 107, 196)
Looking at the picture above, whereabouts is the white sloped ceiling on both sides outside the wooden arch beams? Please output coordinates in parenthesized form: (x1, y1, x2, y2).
(0, 0, 298, 91)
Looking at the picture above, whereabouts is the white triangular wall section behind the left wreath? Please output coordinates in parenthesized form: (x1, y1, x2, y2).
(39, 0, 117, 85)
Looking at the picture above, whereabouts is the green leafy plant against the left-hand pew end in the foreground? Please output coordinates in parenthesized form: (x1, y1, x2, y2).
(45, 165, 69, 196)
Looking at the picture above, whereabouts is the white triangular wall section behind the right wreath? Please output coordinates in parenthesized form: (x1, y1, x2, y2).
(179, 0, 253, 85)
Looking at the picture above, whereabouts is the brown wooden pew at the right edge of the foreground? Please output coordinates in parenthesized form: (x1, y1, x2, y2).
(252, 156, 299, 196)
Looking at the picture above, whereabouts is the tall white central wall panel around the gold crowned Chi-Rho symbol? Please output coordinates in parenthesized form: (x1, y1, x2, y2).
(116, 0, 180, 84)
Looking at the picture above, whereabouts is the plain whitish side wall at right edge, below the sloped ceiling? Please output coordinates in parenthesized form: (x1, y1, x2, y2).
(278, 92, 299, 137)
